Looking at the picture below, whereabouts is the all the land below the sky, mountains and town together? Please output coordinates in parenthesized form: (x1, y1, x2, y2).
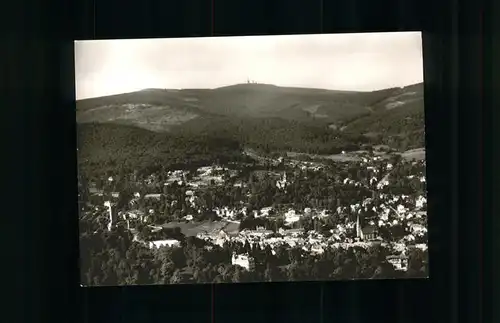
(76, 84, 428, 286)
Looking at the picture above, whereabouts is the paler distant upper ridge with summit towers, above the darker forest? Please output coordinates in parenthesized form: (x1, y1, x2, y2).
(77, 84, 422, 131)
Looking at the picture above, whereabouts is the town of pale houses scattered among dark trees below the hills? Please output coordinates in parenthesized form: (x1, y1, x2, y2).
(79, 148, 428, 285)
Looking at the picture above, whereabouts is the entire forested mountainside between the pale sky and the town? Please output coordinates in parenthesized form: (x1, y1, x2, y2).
(77, 84, 425, 174)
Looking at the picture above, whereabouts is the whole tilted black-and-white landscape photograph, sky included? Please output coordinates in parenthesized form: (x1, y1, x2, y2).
(75, 32, 428, 286)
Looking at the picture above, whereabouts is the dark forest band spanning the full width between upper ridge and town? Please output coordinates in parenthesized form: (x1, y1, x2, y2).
(78, 106, 425, 180)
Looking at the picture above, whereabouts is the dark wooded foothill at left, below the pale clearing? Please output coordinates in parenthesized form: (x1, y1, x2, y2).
(78, 124, 248, 177)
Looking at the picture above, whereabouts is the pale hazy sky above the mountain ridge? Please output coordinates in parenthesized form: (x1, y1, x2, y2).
(75, 32, 423, 100)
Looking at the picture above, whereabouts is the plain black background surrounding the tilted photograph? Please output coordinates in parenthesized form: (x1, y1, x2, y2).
(4, 0, 488, 323)
